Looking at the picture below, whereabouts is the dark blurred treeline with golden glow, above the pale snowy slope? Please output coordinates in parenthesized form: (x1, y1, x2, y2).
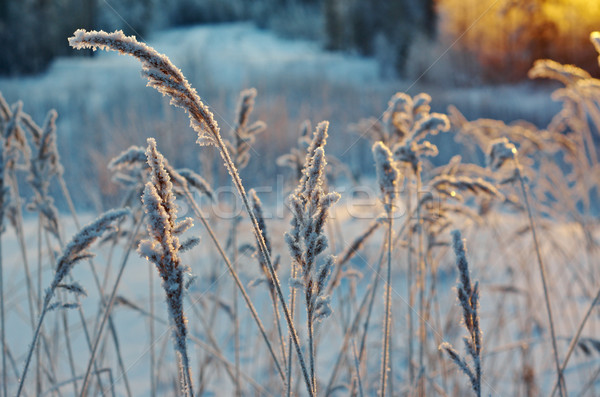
(0, 0, 600, 81)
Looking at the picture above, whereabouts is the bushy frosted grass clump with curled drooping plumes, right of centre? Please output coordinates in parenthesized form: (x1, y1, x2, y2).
(355, 92, 504, 395)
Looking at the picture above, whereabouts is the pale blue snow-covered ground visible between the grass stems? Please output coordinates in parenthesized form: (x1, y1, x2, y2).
(3, 198, 598, 396)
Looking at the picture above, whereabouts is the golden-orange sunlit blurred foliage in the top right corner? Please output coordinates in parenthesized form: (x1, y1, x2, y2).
(438, 0, 600, 81)
